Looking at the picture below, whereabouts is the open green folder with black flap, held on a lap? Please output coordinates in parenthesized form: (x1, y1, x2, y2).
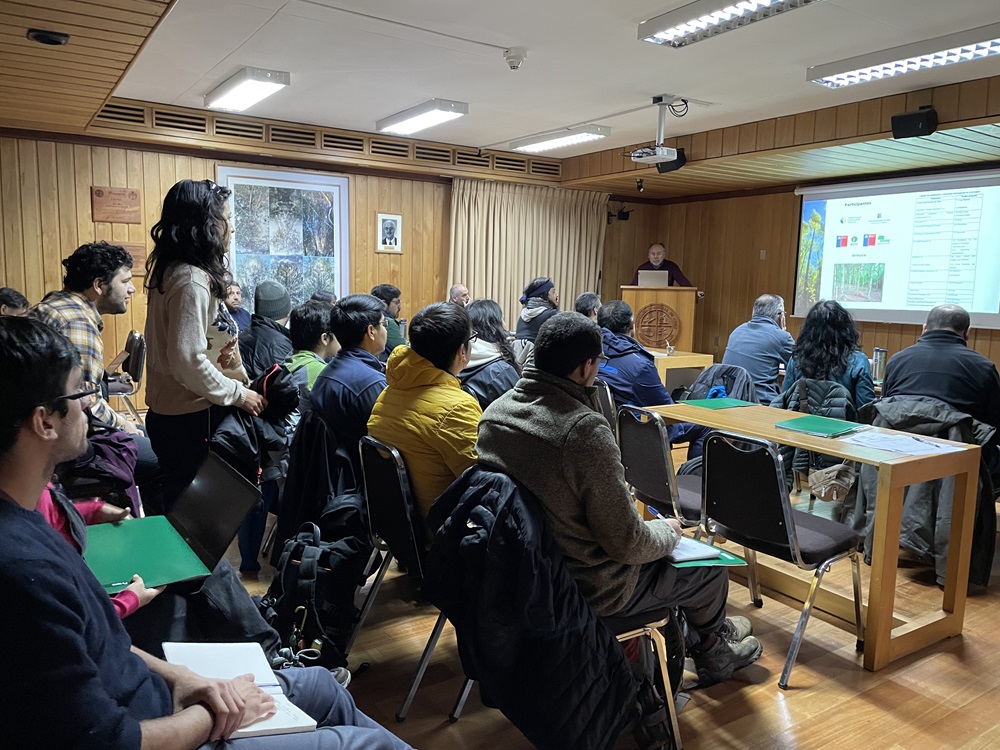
(84, 453, 260, 594)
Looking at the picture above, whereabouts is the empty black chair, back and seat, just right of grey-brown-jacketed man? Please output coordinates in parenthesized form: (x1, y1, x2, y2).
(618, 406, 702, 535)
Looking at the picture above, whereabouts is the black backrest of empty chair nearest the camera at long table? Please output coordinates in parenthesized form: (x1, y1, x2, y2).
(701, 432, 805, 567)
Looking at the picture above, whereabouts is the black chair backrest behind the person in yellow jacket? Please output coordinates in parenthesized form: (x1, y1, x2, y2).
(359, 435, 425, 578)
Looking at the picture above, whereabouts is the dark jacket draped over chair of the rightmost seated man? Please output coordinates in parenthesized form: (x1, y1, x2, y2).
(849, 396, 996, 586)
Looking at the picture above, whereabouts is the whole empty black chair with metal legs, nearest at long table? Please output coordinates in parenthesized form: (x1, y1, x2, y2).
(702, 432, 864, 690)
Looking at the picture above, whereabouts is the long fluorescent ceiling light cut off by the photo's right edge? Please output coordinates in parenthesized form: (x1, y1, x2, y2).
(806, 23, 1000, 89)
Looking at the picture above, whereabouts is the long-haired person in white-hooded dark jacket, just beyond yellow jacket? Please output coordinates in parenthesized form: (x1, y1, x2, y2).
(458, 299, 521, 409)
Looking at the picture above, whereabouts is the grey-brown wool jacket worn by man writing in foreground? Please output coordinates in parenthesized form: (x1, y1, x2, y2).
(476, 365, 677, 616)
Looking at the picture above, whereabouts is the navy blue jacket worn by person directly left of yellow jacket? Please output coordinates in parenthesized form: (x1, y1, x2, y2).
(310, 349, 385, 468)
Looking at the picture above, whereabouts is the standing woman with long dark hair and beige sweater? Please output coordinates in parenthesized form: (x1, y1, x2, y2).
(146, 180, 265, 511)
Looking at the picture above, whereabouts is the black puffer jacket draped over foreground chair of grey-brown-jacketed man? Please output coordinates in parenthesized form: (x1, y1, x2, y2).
(424, 465, 635, 750)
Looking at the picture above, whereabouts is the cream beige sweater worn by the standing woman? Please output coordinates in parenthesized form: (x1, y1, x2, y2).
(146, 264, 247, 415)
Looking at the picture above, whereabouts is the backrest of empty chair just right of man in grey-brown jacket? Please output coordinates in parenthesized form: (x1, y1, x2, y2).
(618, 406, 683, 519)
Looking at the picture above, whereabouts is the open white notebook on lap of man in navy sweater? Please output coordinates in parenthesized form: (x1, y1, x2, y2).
(163, 642, 316, 739)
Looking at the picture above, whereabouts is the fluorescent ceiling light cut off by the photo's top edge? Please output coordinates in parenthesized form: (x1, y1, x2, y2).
(639, 0, 820, 47)
